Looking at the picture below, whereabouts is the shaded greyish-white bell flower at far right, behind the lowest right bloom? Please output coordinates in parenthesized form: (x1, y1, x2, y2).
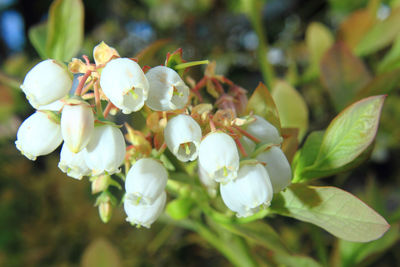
(256, 146, 292, 193)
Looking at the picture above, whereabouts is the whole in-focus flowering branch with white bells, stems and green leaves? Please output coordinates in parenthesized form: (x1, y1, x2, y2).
(9, 0, 396, 266)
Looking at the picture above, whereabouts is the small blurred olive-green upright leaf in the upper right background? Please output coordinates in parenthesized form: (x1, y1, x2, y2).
(306, 22, 334, 75)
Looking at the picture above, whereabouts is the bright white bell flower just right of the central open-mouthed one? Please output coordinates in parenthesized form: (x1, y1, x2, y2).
(199, 132, 239, 183)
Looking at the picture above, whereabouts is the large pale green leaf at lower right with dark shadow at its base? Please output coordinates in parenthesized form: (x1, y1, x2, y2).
(271, 184, 390, 242)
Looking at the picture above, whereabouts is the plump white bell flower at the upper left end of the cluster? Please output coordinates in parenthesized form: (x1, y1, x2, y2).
(21, 59, 72, 109)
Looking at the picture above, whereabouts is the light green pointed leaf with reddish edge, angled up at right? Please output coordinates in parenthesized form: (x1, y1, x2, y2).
(310, 95, 385, 170)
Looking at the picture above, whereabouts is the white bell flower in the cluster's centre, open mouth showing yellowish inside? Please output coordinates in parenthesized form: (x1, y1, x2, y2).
(164, 114, 201, 162)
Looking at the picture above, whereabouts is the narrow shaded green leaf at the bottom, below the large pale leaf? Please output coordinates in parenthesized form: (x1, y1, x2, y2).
(221, 221, 289, 254)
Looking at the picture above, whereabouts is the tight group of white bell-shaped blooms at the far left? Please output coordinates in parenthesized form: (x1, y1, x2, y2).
(15, 59, 125, 179)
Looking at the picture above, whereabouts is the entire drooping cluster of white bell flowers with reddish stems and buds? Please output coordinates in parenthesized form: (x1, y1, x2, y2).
(15, 42, 291, 227)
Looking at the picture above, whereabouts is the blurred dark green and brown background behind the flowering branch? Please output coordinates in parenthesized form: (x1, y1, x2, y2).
(0, 0, 400, 266)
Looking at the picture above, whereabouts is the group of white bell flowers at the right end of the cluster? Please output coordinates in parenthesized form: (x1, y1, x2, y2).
(199, 116, 292, 217)
